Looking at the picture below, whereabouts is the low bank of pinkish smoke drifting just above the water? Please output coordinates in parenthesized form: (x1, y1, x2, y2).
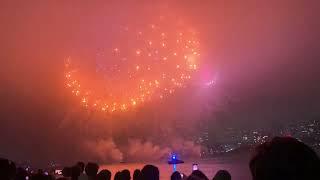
(81, 138, 201, 163)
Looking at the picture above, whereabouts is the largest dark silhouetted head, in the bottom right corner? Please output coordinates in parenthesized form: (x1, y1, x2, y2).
(250, 137, 320, 180)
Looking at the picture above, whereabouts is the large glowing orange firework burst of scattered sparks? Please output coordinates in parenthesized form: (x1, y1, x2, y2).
(65, 16, 200, 112)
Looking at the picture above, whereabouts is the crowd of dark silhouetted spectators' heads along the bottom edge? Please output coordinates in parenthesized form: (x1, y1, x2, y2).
(0, 137, 320, 180)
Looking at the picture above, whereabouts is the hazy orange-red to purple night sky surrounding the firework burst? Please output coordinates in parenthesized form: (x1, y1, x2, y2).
(0, 0, 320, 164)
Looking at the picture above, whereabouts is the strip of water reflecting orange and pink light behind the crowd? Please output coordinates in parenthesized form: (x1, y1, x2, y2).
(100, 159, 251, 180)
